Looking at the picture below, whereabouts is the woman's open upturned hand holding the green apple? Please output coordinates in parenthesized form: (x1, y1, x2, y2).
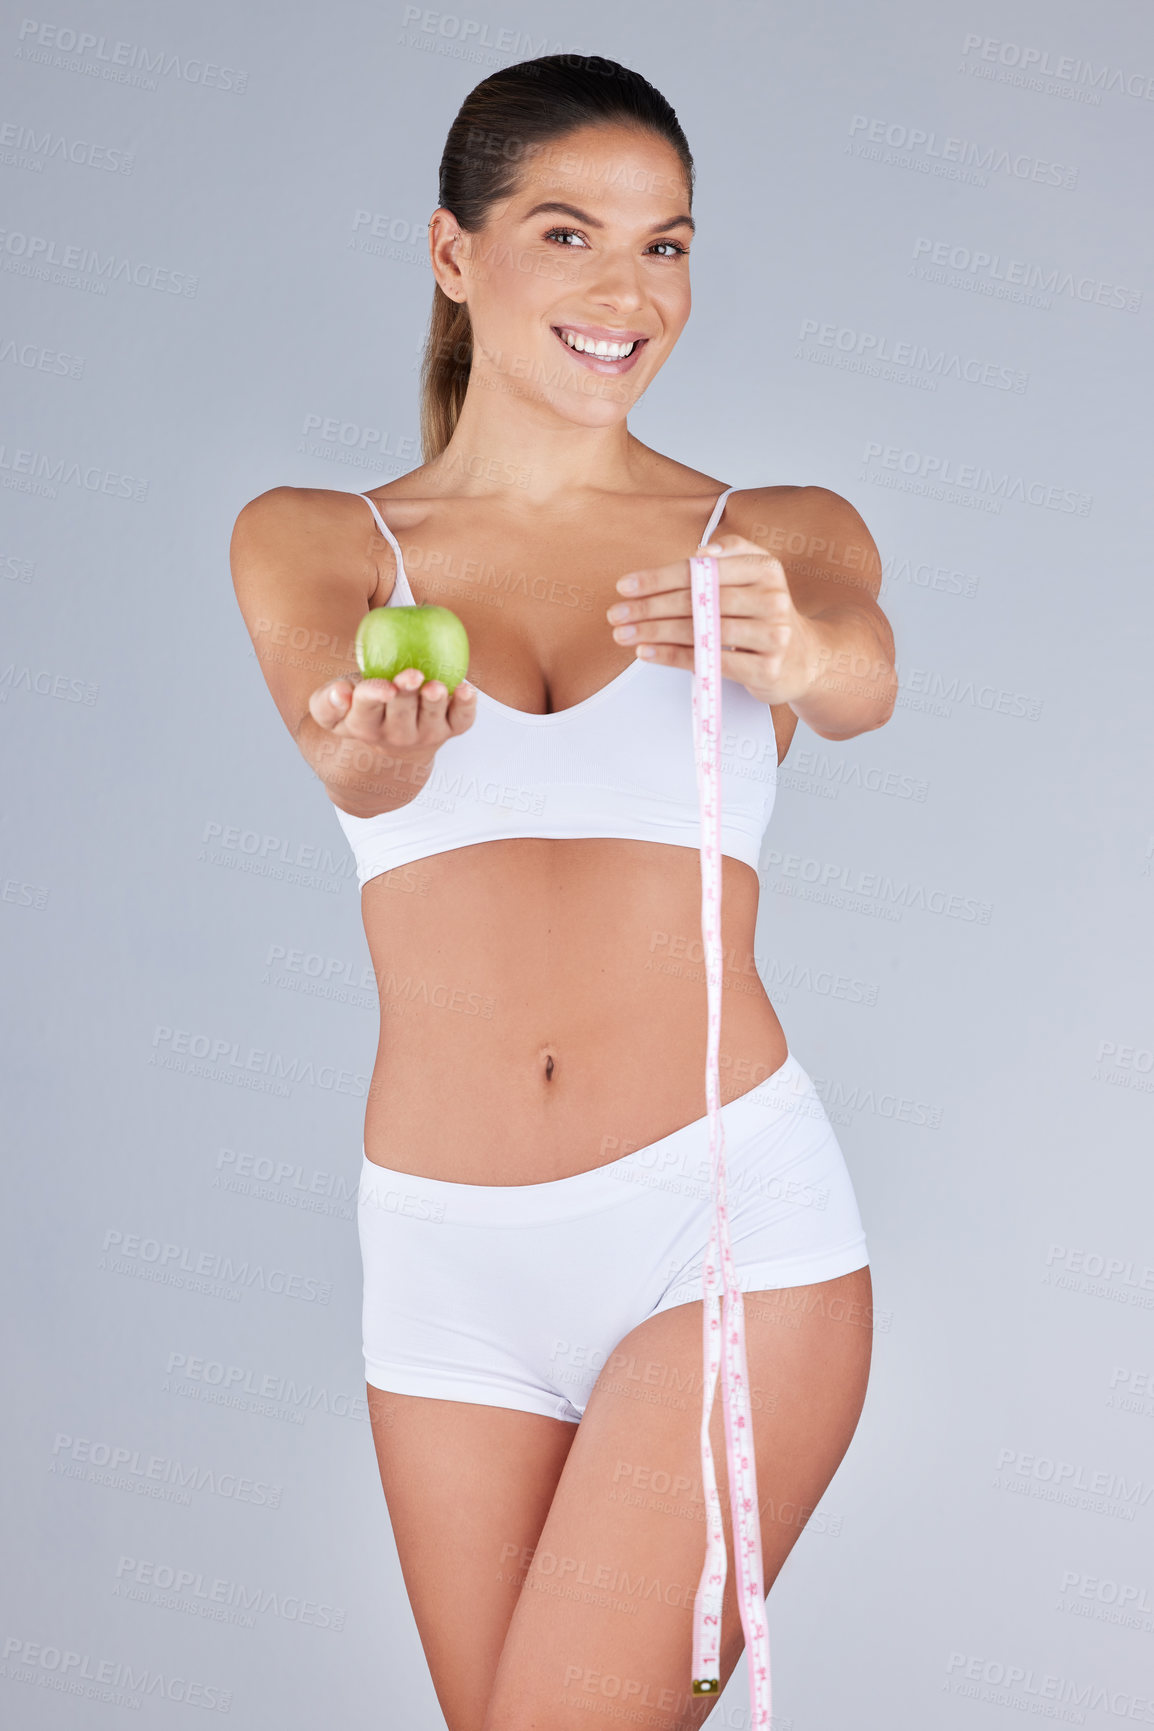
(308, 666, 478, 758)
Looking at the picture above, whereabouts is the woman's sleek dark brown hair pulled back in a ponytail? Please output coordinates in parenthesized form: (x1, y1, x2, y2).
(420, 54, 694, 462)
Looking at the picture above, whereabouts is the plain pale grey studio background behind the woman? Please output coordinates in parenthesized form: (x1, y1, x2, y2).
(0, 0, 1154, 1731)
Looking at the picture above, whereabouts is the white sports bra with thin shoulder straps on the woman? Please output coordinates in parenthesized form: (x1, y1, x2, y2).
(334, 486, 777, 886)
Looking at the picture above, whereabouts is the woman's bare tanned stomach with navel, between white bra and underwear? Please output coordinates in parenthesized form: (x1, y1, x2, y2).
(362, 838, 787, 1184)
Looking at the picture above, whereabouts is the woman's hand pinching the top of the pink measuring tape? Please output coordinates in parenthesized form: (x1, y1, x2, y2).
(607, 535, 818, 703)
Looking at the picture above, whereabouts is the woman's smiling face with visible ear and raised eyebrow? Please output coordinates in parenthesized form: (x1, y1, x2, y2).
(433, 126, 692, 426)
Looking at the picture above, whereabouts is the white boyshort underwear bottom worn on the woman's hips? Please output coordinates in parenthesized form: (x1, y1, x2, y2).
(358, 1052, 869, 1425)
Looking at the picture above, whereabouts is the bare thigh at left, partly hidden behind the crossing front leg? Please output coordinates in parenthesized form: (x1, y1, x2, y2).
(367, 1383, 576, 1731)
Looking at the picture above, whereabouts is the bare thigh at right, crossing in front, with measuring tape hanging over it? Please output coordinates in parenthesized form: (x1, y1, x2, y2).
(484, 1267, 872, 1731)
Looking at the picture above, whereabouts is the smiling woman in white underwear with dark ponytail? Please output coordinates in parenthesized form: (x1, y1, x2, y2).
(234, 55, 896, 1731)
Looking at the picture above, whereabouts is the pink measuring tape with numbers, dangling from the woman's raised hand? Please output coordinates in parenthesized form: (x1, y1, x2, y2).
(689, 557, 770, 1731)
